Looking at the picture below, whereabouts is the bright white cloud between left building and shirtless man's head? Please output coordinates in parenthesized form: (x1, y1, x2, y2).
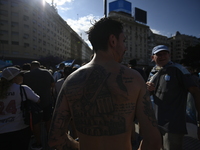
(66, 14, 101, 47)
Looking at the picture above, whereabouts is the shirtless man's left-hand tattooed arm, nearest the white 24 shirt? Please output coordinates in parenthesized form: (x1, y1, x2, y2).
(48, 90, 78, 150)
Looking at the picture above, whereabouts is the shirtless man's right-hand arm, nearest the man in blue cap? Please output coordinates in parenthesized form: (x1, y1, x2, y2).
(136, 81, 162, 150)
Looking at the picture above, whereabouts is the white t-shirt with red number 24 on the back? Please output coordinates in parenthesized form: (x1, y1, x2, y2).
(0, 83, 40, 134)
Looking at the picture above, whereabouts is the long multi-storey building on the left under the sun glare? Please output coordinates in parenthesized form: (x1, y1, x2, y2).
(0, 0, 92, 65)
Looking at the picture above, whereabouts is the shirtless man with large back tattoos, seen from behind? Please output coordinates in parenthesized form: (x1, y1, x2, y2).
(49, 18, 162, 150)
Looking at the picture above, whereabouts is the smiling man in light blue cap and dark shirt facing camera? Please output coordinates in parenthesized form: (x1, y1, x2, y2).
(146, 45, 200, 150)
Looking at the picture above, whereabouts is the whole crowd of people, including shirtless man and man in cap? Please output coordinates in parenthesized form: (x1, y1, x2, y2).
(0, 18, 200, 150)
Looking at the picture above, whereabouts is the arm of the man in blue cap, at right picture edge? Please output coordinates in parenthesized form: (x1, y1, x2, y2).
(189, 87, 200, 140)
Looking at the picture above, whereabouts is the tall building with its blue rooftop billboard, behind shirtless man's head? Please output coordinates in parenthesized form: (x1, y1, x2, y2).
(109, 0, 149, 66)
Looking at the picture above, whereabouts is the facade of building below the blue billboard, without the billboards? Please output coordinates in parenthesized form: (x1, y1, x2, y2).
(109, 11, 149, 66)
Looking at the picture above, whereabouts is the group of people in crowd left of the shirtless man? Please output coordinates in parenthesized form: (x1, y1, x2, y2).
(0, 61, 77, 150)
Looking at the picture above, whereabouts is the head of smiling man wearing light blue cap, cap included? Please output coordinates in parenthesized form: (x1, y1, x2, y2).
(151, 45, 170, 67)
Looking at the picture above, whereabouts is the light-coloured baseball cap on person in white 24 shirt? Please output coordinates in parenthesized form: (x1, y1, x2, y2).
(2, 67, 23, 80)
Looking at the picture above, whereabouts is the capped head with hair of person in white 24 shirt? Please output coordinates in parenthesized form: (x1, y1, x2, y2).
(0, 67, 23, 99)
